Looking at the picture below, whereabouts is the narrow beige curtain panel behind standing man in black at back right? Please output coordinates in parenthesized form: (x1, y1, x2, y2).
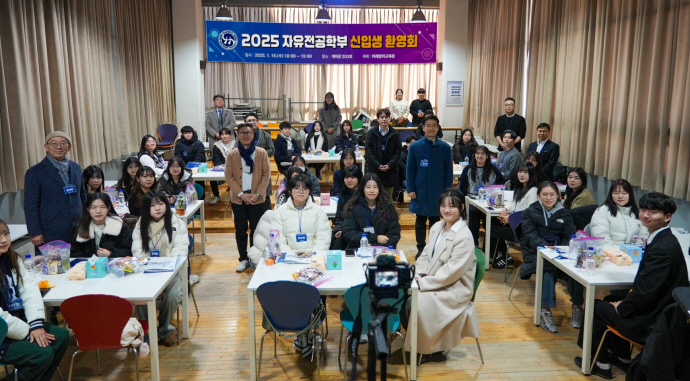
(463, 0, 528, 140)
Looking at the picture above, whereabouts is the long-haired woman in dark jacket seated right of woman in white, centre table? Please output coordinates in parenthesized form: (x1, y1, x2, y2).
(342, 173, 400, 249)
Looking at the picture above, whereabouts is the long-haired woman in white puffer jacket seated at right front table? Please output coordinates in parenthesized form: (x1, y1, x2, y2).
(589, 179, 649, 245)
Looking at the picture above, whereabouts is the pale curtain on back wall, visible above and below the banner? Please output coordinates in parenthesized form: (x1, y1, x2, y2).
(204, 7, 438, 120)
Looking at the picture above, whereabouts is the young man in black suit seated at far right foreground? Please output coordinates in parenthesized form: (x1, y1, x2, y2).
(575, 192, 688, 378)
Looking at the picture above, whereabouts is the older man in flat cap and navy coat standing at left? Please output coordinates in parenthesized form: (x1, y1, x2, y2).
(24, 131, 86, 246)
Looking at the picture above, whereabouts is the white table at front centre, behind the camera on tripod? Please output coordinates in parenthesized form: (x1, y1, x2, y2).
(247, 252, 419, 381)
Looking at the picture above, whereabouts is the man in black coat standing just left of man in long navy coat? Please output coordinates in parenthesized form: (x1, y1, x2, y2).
(366, 108, 402, 199)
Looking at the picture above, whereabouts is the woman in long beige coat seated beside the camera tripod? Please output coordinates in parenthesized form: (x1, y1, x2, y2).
(405, 189, 479, 361)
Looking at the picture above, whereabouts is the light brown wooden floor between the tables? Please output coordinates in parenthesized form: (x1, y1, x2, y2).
(30, 171, 624, 381)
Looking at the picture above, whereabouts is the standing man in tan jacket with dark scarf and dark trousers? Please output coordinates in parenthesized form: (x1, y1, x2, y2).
(225, 123, 271, 273)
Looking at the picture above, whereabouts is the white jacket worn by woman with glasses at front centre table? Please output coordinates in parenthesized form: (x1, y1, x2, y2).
(271, 198, 331, 252)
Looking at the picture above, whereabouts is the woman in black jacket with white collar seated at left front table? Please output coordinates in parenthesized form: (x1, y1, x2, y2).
(70, 193, 132, 258)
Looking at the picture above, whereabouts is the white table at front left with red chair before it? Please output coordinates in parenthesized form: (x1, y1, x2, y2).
(41, 256, 189, 381)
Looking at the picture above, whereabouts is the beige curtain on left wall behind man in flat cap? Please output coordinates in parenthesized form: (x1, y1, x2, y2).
(0, 0, 174, 193)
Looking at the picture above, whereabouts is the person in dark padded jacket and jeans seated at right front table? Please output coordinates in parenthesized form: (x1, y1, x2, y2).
(520, 181, 584, 333)
